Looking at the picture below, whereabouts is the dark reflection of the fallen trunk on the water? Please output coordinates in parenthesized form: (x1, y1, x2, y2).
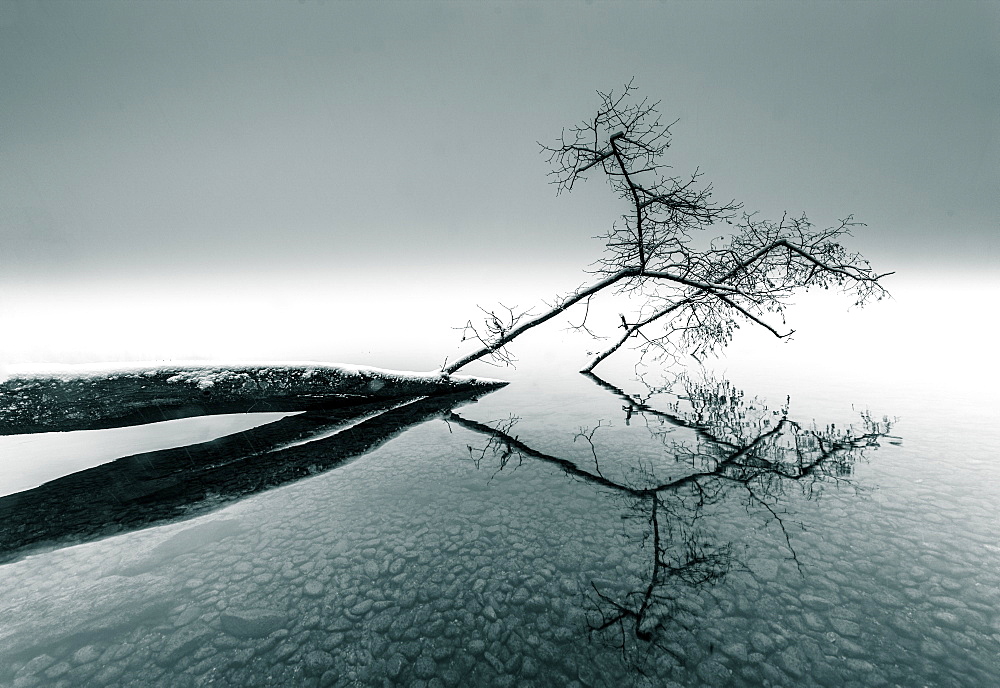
(0, 391, 498, 562)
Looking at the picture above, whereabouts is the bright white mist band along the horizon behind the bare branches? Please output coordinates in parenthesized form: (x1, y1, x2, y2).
(0, 270, 1000, 376)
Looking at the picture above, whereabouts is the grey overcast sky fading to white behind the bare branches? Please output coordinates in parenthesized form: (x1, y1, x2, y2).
(0, 0, 1000, 368)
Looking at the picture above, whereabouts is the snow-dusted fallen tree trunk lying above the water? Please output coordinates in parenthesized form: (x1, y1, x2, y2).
(0, 364, 503, 435)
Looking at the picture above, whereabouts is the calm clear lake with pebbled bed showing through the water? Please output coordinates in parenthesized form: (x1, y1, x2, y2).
(0, 276, 1000, 687)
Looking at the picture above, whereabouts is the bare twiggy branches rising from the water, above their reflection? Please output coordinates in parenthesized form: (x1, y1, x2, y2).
(442, 82, 892, 374)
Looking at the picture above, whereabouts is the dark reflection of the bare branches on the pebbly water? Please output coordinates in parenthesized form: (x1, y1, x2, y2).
(447, 375, 891, 652)
